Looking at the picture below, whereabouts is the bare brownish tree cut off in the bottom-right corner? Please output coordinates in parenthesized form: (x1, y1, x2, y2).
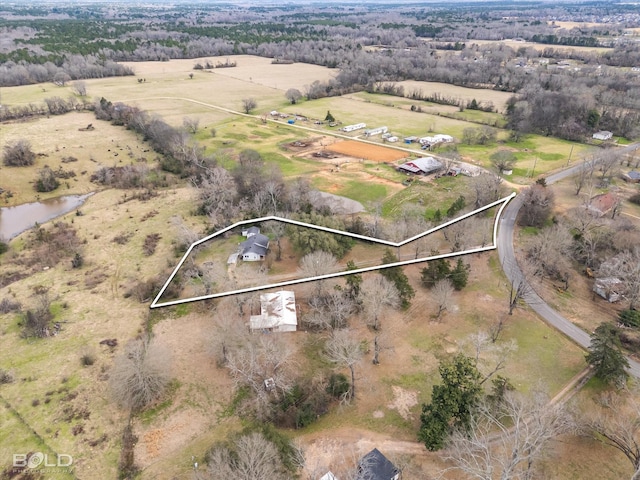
(581, 390, 640, 480)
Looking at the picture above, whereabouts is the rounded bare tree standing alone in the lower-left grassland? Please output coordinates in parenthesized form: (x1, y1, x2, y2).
(109, 338, 171, 411)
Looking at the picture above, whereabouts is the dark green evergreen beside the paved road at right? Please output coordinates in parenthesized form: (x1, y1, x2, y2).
(585, 323, 629, 384)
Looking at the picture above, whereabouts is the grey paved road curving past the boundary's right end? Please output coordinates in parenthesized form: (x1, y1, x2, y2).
(497, 144, 640, 378)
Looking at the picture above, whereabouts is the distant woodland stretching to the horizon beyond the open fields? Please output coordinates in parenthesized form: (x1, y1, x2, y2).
(0, 2, 640, 140)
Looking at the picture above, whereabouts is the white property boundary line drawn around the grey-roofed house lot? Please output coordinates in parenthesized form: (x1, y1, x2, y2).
(149, 193, 516, 308)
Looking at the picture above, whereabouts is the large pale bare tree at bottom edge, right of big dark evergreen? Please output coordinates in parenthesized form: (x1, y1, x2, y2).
(445, 392, 574, 480)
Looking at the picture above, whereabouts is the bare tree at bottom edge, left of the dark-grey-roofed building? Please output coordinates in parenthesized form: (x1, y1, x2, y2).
(206, 432, 290, 480)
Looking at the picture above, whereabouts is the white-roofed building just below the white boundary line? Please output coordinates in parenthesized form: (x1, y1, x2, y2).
(249, 290, 298, 332)
